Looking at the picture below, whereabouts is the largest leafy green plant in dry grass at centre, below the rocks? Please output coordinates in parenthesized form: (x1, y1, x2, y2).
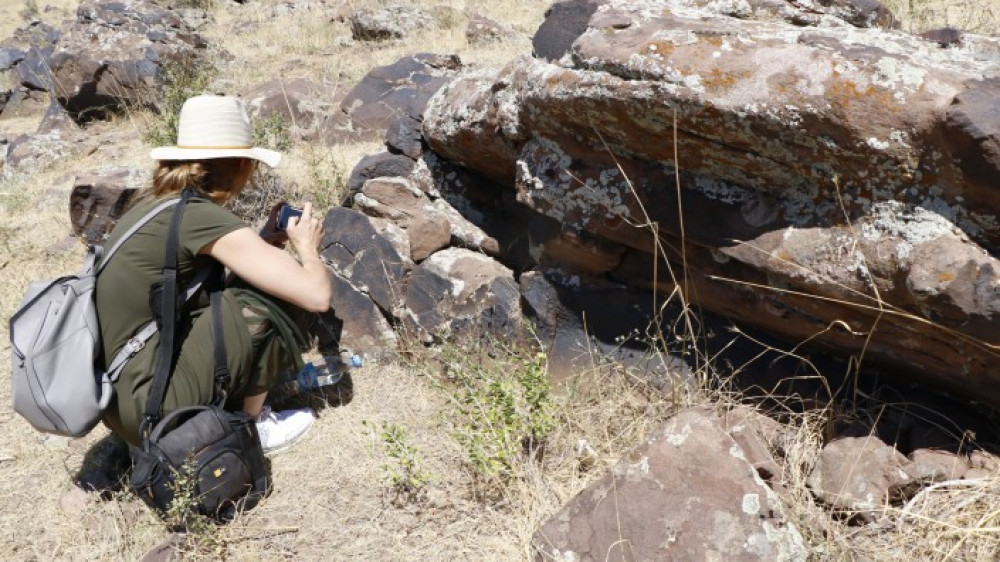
(441, 344, 556, 484)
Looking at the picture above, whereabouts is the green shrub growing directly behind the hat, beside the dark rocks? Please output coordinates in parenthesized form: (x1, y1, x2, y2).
(144, 57, 217, 146)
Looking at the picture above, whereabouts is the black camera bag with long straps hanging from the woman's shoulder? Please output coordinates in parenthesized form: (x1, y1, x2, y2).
(129, 190, 271, 521)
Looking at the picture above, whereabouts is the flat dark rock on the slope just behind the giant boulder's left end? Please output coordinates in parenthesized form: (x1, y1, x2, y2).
(341, 54, 461, 131)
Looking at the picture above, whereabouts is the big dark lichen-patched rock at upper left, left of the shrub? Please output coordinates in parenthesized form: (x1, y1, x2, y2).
(46, 0, 206, 122)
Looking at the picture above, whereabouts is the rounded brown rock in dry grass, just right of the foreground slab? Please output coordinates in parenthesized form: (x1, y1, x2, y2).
(807, 435, 912, 521)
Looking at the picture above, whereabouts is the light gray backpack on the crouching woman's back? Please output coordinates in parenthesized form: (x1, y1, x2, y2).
(10, 199, 207, 437)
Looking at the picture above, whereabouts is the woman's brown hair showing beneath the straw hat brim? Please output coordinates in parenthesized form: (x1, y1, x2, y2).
(148, 158, 257, 205)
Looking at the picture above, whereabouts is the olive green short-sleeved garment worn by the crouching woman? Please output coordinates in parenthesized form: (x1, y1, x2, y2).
(97, 198, 249, 443)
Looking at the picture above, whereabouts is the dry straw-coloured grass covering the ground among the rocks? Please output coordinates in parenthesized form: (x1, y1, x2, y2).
(0, 0, 1000, 560)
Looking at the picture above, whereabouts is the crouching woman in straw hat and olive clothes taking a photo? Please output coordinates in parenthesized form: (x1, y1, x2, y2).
(97, 95, 332, 452)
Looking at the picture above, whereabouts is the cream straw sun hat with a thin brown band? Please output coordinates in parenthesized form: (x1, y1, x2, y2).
(149, 95, 281, 168)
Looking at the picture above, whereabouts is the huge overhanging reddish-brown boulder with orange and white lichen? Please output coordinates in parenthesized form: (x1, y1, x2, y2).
(423, 0, 1000, 404)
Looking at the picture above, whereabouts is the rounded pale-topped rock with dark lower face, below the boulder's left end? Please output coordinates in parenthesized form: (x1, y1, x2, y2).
(403, 248, 521, 341)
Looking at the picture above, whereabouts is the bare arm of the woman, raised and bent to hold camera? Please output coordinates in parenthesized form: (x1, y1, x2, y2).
(200, 203, 333, 312)
